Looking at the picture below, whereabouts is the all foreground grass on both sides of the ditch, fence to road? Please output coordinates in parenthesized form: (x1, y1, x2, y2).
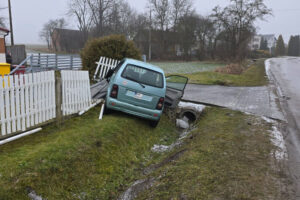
(0, 106, 285, 200)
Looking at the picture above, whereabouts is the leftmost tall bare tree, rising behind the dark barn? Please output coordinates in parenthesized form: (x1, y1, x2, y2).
(68, 0, 92, 41)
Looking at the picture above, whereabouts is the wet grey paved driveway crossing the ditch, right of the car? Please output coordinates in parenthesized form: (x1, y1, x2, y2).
(183, 84, 285, 120)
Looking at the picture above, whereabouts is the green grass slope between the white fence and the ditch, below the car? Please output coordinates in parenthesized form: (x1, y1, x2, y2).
(0, 108, 178, 200)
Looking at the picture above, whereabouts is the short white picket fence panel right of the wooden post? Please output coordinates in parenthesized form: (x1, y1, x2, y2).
(61, 70, 92, 116)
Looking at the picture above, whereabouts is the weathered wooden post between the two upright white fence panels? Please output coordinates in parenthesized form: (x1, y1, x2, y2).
(55, 71, 63, 126)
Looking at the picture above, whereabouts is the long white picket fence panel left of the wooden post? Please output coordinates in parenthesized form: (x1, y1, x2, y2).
(0, 71, 56, 136)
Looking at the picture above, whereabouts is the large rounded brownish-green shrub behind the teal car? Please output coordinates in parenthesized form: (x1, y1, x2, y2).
(80, 35, 141, 76)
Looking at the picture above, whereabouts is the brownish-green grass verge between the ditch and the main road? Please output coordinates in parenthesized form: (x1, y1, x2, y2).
(137, 108, 284, 200)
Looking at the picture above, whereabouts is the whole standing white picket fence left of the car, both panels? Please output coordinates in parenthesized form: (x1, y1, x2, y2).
(0, 71, 92, 138)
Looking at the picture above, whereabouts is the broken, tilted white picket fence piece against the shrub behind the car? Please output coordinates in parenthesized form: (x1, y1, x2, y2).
(93, 57, 120, 81)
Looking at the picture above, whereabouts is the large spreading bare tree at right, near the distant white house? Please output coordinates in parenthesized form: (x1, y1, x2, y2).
(212, 0, 271, 59)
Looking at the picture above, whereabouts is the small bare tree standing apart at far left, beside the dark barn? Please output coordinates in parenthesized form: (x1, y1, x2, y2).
(40, 18, 67, 51)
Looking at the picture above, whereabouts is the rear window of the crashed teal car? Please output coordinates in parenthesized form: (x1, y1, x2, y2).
(122, 64, 164, 88)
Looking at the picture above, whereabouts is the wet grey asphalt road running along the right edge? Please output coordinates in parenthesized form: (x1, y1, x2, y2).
(268, 57, 300, 199)
